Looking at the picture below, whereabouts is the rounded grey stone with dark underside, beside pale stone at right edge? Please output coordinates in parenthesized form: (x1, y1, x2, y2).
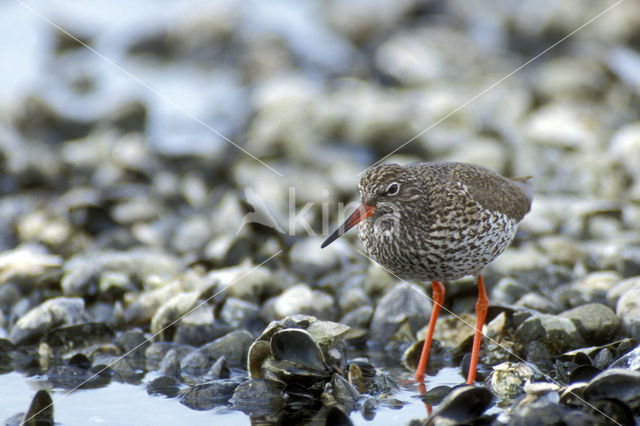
(560, 303, 620, 345)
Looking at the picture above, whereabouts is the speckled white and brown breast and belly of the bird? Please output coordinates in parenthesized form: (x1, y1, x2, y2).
(358, 205, 517, 281)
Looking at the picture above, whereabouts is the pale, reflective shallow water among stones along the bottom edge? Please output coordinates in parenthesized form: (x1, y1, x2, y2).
(0, 368, 470, 426)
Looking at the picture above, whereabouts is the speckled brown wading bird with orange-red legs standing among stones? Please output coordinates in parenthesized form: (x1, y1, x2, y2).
(321, 162, 533, 385)
